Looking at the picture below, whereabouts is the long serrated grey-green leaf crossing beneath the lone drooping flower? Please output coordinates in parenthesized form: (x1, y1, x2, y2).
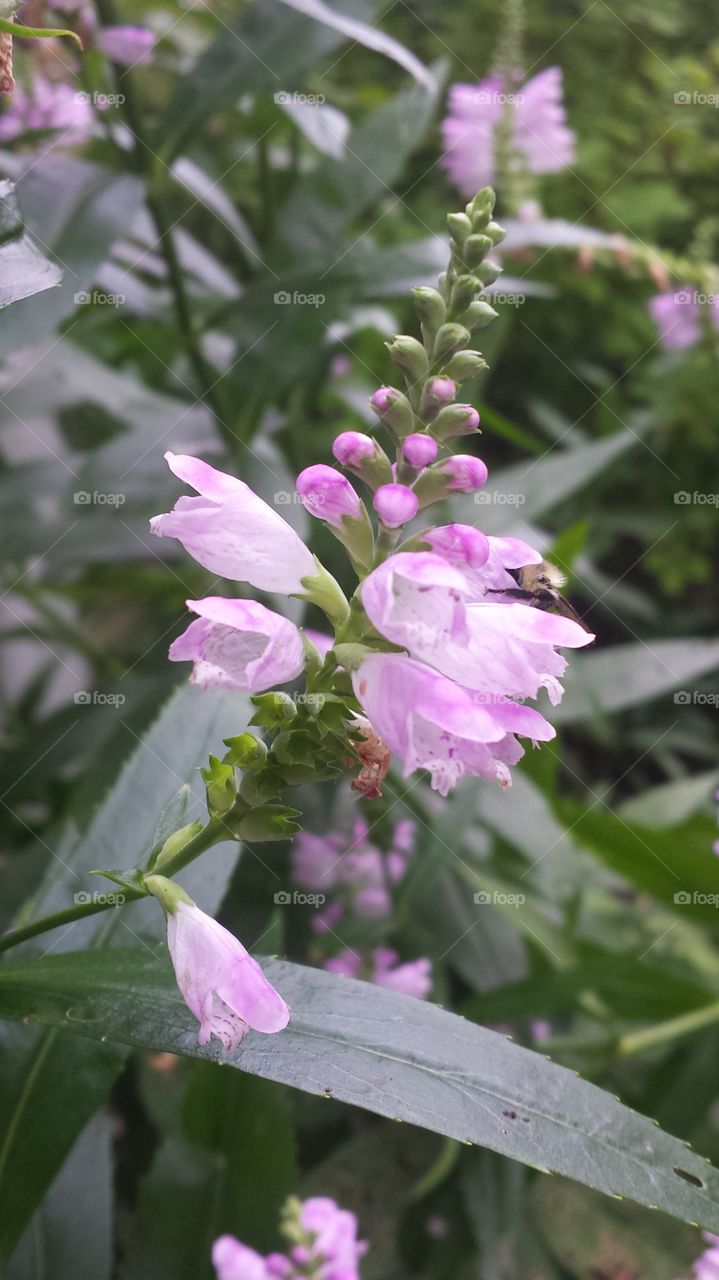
(0, 948, 719, 1231)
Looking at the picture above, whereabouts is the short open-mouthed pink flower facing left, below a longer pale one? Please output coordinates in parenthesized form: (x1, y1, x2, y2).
(170, 595, 304, 694)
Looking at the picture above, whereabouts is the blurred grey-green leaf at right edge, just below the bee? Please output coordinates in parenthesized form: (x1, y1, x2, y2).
(553, 639, 719, 723)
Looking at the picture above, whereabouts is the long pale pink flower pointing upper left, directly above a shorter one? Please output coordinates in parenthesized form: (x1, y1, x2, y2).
(150, 453, 316, 595)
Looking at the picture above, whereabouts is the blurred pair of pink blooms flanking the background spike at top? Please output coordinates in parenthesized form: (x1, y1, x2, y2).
(443, 67, 574, 200)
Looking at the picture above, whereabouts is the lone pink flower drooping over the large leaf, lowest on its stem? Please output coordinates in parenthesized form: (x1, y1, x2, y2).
(146, 876, 289, 1053)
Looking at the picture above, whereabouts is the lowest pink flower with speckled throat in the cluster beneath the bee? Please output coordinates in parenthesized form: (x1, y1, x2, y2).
(353, 653, 554, 796)
